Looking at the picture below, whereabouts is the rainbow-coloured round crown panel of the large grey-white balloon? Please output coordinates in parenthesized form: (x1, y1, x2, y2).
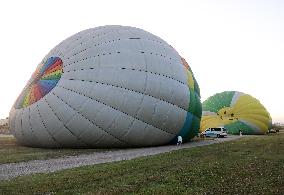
(16, 57, 63, 108)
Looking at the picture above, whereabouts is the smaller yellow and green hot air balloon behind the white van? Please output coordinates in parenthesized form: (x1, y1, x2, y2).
(200, 91, 271, 134)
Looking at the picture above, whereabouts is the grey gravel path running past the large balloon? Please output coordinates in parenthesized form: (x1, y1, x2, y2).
(0, 136, 240, 180)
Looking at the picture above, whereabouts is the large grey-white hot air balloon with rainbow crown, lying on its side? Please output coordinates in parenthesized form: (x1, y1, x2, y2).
(9, 26, 201, 148)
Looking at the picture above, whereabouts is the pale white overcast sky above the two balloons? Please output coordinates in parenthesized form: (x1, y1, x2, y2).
(0, 0, 284, 123)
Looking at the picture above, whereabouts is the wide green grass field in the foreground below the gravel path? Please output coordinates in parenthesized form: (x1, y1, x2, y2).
(0, 132, 284, 194)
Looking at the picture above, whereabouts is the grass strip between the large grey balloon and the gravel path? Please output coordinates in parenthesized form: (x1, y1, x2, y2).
(0, 136, 110, 164)
